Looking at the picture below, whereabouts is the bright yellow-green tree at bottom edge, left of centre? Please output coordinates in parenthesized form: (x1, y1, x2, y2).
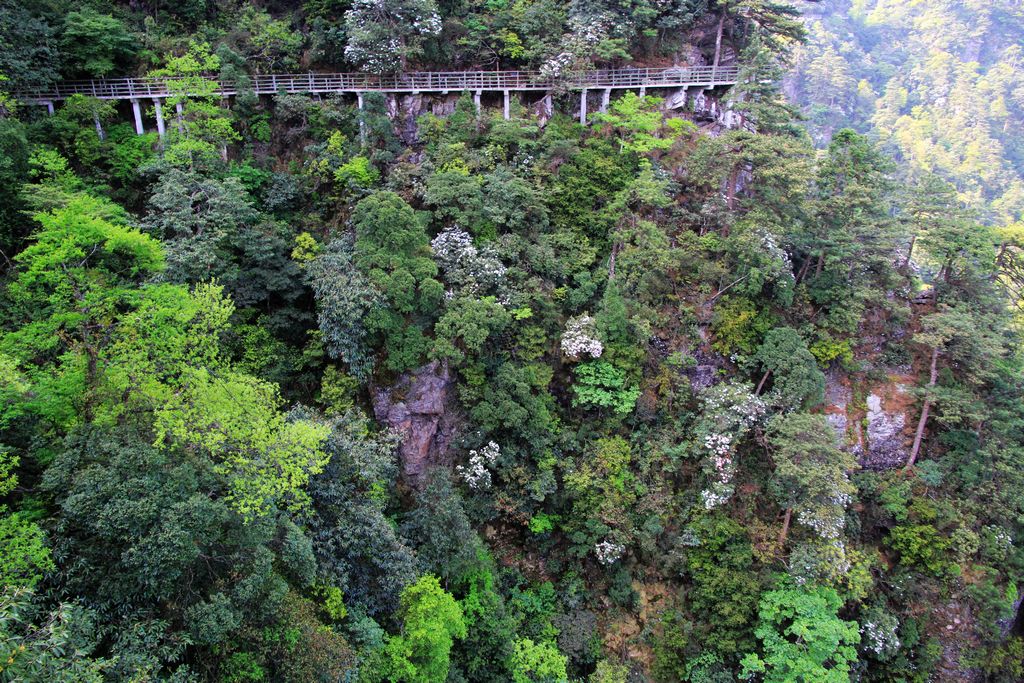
(370, 575, 466, 683)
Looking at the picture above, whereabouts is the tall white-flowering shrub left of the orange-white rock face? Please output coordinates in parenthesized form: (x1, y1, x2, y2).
(696, 382, 767, 510)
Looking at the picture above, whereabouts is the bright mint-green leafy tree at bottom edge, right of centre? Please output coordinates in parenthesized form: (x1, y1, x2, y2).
(741, 585, 860, 683)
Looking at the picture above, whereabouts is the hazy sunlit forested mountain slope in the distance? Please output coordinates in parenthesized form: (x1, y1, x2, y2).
(787, 0, 1024, 223)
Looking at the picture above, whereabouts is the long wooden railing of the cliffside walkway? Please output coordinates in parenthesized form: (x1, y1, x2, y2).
(13, 67, 739, 102)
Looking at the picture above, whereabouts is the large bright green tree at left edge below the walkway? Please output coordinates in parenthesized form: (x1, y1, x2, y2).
(0, 196, 164, 426)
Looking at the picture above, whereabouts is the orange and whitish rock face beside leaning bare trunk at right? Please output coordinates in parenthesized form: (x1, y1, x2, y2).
(825, 373, 914, 470)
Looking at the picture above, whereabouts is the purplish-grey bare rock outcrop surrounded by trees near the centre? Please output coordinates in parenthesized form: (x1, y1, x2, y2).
(374, 360, 458, 486)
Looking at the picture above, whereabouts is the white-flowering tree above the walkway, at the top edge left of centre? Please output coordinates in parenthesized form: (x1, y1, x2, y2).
(345, 0, 441, 74)
